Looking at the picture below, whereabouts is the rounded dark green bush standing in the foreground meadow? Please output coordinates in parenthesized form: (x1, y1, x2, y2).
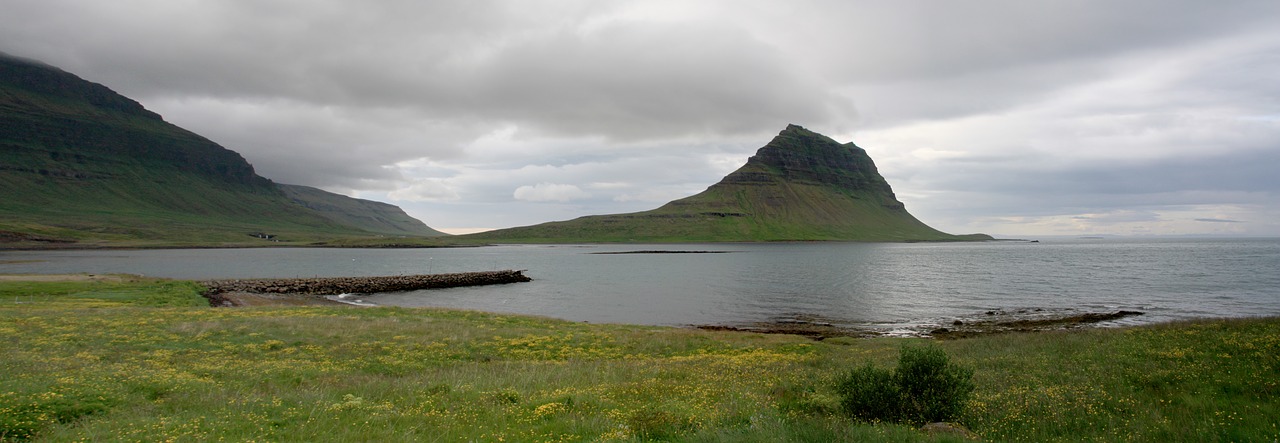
(836, 346, 974, 425)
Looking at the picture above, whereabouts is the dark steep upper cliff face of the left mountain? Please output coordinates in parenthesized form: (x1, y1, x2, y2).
(0, 54, 273, 186)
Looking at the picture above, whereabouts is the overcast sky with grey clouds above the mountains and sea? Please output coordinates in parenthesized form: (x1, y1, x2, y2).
(0, 0, 1280, 236)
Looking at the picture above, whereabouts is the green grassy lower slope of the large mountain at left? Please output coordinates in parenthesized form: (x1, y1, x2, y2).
(0, 154, 422, 247)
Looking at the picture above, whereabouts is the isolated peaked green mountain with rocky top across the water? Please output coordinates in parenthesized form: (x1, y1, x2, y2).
(466, 124, 991, 243)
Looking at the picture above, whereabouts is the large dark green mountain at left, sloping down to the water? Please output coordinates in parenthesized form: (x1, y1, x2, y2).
(0, 52, 439, 247)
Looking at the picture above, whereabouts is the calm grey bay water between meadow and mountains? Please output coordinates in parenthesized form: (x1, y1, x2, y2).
(0, 238, 1280, 330)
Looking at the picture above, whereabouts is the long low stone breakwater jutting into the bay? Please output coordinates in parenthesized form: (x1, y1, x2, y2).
(201, 270, 532, 298)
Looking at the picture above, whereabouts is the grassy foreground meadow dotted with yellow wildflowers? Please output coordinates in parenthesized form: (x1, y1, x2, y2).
(0, 277, 1280, 442)
